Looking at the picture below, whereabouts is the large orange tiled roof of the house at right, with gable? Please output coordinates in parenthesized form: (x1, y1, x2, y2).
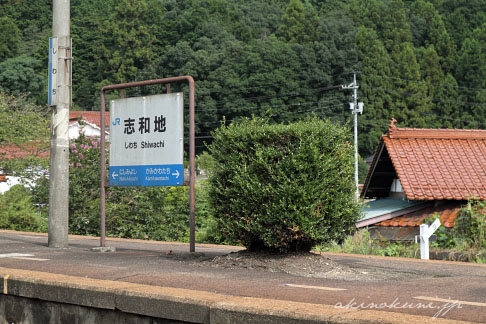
(363, 122, 486, 200)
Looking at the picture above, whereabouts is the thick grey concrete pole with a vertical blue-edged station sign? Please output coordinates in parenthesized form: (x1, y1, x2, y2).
(48, 0, 72, 248)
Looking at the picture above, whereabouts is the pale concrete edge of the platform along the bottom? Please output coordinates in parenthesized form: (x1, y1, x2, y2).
(0, 267, 478, 324)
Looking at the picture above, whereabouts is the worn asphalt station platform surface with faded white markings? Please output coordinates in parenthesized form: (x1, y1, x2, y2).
(0, 231, 486, 323)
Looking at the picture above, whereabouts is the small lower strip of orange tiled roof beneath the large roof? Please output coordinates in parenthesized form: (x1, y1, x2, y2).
(375, 202, 461, 228)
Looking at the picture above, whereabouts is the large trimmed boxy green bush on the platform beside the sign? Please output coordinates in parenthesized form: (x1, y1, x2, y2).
(209, 118, 359, 252)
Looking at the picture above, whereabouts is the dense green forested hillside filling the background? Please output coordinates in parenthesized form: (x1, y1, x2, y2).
(0, 0, 486, 155)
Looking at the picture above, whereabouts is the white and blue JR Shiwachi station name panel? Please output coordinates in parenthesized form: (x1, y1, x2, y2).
(109, 93, 184, 186)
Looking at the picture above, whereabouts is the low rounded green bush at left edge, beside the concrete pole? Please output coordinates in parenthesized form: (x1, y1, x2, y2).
(0, 185, 47, 231)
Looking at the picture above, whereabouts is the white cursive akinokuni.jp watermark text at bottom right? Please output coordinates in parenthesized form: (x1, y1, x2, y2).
(334, 297, 462, 318)
